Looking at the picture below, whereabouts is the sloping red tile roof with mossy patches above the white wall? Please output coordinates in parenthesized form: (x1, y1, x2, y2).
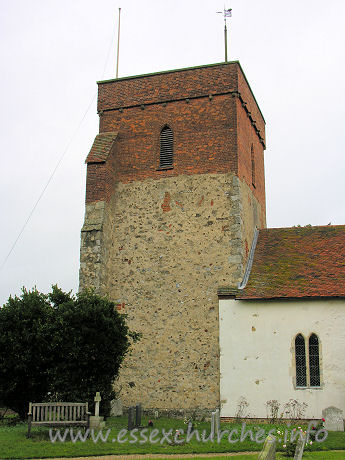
(236, 225, 345, 299)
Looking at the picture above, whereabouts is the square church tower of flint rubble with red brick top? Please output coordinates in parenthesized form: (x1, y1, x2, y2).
(80, 62, 266, 413)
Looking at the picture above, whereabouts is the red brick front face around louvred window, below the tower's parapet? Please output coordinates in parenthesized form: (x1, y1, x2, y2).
(97, 96, 237, 188)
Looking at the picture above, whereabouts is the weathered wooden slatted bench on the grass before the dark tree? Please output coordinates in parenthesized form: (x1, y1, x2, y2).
(28, 402, 91, 437)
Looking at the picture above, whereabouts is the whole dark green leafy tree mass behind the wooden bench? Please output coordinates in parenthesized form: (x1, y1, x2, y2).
(0, 286, 139, 417)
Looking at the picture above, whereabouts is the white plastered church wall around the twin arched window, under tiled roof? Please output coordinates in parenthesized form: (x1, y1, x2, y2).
(219, 299, 345, 418)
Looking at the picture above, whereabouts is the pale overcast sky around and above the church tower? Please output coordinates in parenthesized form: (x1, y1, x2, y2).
(0, 0, 345, 304)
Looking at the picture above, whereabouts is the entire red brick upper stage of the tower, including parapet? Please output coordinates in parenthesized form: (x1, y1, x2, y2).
(86, 61, 265, 204)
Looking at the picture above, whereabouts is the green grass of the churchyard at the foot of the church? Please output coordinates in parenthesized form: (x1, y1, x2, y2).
(0, 417, 345, 460)
